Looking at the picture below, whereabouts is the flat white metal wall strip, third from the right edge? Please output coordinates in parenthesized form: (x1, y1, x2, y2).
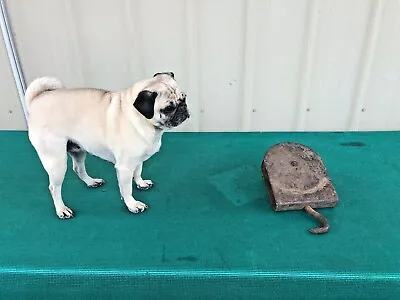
(250, 0, 311, 130)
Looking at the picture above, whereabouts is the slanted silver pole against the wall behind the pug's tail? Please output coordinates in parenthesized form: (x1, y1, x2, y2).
(0, 0, 28, 120)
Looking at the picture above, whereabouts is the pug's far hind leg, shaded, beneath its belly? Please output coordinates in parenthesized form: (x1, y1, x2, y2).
(67, 141, 105, 188)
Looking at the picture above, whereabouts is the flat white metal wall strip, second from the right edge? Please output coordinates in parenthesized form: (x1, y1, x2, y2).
(299, 0, 370, 130)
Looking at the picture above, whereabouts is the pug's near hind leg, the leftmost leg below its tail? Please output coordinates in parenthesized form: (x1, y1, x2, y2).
(30, 134, 74, 219)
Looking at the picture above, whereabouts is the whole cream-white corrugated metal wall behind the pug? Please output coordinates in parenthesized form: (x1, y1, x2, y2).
(1, 0, 400, 131)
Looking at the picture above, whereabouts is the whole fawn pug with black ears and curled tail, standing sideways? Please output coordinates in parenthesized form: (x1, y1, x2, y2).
(25, 72, 190, 219)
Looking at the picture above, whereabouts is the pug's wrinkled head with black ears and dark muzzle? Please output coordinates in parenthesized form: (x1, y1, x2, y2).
(134, 72, 190, 129)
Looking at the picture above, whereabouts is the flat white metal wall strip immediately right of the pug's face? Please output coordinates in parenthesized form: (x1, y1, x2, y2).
(194, 0, 245, 131)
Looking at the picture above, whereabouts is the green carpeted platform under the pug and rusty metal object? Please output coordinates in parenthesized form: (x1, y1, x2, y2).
(0, 132, 400, 299)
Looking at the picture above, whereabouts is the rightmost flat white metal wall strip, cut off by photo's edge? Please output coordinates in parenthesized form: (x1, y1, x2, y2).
(354, 0, 400, 130)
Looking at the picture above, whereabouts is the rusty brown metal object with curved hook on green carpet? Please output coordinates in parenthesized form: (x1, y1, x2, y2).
(261, 142, 338, 234)
